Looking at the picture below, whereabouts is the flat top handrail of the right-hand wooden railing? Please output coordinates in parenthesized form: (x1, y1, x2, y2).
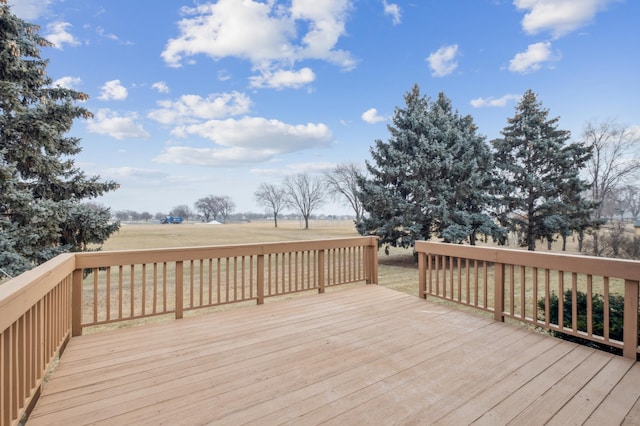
(415, 241, 640, 280)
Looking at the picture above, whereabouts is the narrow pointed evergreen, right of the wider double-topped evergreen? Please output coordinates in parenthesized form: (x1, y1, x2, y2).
(492, 90, 593, 250)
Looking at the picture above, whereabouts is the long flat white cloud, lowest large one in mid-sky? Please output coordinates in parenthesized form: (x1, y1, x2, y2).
(156, 117, 332, 166)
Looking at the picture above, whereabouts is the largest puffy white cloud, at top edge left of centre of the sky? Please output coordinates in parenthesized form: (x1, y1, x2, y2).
(162, 0, 355, 87)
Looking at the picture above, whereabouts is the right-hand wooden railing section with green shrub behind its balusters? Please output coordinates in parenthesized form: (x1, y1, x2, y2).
(415, 241, 640, 360)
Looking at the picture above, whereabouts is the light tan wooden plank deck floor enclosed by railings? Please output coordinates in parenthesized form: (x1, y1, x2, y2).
(27, 285, 640, 426)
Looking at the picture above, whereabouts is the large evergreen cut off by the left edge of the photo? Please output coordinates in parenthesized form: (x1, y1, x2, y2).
(0, 0, 119, 273)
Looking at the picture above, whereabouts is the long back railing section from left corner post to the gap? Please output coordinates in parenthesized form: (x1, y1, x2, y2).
(74, 238, 377, 335)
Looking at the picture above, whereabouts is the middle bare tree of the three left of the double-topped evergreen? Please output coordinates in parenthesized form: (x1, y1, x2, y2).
(284, 173, 325, 229)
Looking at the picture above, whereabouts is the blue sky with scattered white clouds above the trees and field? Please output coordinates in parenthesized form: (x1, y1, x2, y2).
(9, 0, 640, 218)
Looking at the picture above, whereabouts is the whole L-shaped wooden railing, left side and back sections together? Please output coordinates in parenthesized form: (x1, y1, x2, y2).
(0, 237, 378, 426)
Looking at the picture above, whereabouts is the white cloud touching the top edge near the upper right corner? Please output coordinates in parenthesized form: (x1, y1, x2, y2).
(513, 0, 618, 37)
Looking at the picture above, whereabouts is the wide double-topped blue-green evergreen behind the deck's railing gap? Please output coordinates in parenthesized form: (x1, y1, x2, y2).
(357, 85, 497, 251)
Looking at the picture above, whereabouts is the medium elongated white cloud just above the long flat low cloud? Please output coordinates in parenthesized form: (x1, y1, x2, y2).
(148, 92, 251, 124)
